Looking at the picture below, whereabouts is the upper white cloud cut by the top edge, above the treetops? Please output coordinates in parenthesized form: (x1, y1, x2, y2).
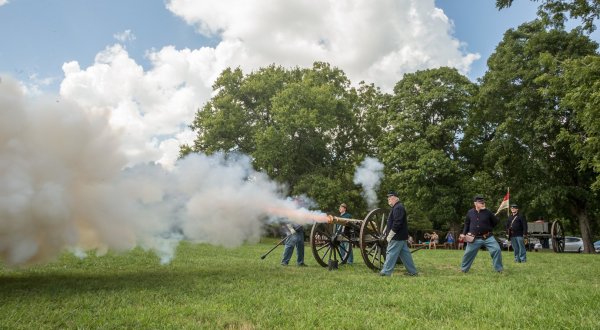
(167, 0, 479, 90)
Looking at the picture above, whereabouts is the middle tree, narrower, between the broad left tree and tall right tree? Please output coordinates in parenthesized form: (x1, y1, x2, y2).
(380, 68, 477, 230)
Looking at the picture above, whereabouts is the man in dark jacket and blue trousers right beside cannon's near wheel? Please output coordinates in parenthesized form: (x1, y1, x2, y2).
(379, 191, 417, 276)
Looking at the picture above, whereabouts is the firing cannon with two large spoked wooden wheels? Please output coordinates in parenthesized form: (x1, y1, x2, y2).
(310, 209, 416, 271)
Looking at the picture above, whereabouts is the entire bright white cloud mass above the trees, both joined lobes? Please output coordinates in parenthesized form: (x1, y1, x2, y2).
(60, 0, 479, 166)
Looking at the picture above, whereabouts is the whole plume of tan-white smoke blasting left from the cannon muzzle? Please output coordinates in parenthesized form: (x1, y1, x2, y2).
(0, 79, 326, 266)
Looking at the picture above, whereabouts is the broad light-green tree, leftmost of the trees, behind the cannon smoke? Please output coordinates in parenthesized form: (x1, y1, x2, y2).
(181, 62, 386, 214)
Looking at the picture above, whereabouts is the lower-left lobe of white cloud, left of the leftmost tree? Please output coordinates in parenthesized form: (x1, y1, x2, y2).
(60, 44, 217, 167)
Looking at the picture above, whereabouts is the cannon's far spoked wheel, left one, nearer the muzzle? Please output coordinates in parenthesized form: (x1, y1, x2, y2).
(310, 222, 352, 267)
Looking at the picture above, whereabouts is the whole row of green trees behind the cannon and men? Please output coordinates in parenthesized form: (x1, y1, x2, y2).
(181, 5, 600, 252)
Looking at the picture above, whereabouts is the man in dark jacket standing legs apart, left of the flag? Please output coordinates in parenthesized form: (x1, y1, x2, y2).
(460, 195, 504, 273)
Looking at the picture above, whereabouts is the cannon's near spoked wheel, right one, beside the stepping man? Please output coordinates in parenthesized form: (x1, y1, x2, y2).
(360, 209, 387, 271)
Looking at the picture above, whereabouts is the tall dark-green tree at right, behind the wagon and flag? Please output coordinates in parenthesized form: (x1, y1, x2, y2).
(466, 21, 598, 251)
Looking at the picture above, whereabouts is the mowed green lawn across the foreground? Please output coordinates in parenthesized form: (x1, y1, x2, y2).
(0, 240, 600, 329)
